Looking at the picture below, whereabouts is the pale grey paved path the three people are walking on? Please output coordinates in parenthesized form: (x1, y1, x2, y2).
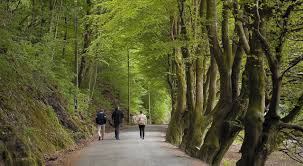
(75, 125, 203, 166)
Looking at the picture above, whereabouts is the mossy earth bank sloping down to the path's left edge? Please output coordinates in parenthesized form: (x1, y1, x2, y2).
(0, 57, 93, 166)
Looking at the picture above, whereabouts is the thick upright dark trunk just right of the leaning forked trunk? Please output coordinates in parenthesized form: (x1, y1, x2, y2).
(237, 28, 265, 166)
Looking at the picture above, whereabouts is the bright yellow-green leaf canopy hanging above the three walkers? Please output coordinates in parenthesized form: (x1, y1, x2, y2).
(89, 0, 172, 120)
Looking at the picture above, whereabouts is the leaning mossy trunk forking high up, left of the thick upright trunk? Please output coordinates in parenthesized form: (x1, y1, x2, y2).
(199, 0, 243, 165)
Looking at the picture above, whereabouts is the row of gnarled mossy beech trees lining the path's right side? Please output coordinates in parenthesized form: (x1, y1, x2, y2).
(167, 0, 302, 165)
